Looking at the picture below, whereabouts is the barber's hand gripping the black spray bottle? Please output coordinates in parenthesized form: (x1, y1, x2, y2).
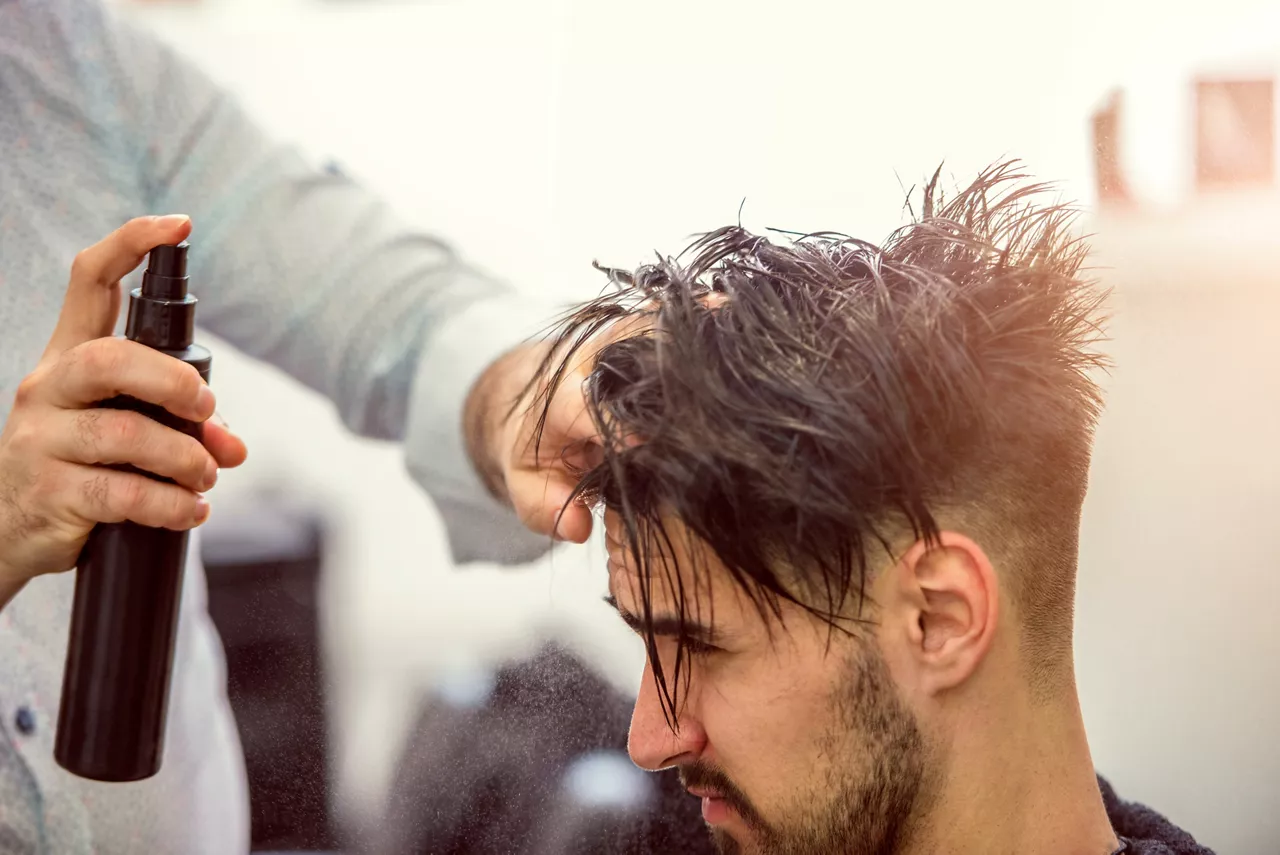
(0, 216, 246, 604)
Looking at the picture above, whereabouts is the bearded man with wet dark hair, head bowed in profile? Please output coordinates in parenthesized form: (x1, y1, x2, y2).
(531, 166, 1206, 855)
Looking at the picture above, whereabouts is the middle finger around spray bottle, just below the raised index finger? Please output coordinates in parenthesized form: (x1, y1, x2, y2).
(46, 338, 216, 421)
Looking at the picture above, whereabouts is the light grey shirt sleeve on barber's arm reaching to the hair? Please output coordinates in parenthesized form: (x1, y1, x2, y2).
(55, 0, 556, 562)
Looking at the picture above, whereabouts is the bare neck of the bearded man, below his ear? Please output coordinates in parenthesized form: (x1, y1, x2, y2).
(902, 683, 1119, 855)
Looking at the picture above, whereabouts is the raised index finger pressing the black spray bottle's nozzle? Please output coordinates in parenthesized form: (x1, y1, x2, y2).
(46, 215, 191, 356)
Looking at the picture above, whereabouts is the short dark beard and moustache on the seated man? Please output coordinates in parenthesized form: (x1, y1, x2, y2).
(680, 650, 927, 855)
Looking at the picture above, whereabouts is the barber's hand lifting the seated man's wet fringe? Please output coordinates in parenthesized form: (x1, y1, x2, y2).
(466, 344, 599, 543)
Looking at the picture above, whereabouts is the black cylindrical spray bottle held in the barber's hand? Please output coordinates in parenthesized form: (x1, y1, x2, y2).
(54, 241, 211, 781)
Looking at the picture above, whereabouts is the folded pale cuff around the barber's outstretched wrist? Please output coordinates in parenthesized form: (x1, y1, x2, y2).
(404, 293, 564, 564)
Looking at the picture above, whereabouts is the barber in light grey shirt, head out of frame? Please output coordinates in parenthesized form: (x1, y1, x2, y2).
(0, 0, 591, 855)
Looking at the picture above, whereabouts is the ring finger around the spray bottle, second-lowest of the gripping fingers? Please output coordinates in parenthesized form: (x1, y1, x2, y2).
(50, 410, 218, 493)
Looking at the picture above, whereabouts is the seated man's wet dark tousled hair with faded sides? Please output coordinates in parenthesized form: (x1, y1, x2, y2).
(535, 163, 1105, 723)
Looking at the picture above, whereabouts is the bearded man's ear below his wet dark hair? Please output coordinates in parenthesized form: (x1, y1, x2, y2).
(893, 531, 1000, 695)
